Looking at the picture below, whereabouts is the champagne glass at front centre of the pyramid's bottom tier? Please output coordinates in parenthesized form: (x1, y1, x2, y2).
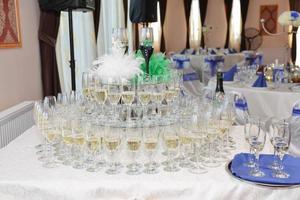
(126, 127, 142, 175)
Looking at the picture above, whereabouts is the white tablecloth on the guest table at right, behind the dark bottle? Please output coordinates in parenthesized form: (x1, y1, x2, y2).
(209, 78, 300, 119)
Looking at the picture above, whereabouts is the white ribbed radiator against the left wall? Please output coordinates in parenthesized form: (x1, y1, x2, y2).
(0, 101, 34, 148)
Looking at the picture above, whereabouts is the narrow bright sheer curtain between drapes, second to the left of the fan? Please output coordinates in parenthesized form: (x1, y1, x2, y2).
(189, 0, 202, 48)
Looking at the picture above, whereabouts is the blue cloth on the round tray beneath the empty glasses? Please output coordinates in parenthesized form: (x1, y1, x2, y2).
(230, 153, 300, 185)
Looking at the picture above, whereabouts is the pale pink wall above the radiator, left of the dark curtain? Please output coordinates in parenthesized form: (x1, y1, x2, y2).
(0, 0, 42, 111)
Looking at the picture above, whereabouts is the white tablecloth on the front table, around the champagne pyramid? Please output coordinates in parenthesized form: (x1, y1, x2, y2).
(0, 126, 300, 200)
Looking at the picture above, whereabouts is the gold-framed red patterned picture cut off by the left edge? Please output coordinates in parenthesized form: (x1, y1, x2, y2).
(0, 0, 22, 48)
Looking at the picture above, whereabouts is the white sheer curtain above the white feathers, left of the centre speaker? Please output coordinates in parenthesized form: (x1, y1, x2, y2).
(97, 0, 125, 57)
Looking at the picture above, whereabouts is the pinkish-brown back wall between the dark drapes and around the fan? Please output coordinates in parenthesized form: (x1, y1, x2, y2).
(164, 0, 289, 63)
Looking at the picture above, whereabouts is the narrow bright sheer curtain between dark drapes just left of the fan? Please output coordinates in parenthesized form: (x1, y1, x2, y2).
(229, 0, 242, 51)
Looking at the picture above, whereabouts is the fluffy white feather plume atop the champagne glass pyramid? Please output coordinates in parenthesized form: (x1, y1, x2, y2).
(92, 52, 143, 80)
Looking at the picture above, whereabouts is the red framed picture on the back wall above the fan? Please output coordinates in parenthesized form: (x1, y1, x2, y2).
(259, 4, 278, 35)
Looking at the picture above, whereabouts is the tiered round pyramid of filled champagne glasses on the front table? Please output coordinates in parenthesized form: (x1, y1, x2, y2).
(34, 86, 235, 175)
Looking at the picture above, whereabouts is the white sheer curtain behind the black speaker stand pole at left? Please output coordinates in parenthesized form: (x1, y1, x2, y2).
(56, 11, 96, 92)
